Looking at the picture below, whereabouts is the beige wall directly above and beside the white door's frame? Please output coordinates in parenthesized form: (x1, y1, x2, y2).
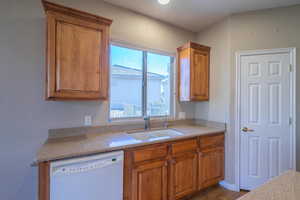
(230, 6, 300, 177)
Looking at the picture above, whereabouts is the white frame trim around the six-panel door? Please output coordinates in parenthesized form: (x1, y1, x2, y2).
(234, 48, 296, 191)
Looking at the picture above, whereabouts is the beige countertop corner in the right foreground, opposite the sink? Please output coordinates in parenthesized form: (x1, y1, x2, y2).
(239, 171, 300, 200)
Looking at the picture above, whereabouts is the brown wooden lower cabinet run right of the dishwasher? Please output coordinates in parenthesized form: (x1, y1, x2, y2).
(124, 133, 224, 200)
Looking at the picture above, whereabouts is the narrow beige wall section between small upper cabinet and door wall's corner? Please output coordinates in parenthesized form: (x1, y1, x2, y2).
(195, 19, 234, 180)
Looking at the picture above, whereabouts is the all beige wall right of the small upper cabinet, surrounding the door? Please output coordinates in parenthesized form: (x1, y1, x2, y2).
(196, 6, 300, 186)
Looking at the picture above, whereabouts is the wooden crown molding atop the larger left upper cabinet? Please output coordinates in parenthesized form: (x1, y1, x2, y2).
(42, 0, 113, 25)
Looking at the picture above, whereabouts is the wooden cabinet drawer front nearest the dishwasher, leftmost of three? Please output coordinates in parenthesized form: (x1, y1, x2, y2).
(133, 144, 168, 162)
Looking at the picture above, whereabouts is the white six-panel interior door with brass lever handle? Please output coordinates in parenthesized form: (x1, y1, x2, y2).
(240, 53, 293, 190)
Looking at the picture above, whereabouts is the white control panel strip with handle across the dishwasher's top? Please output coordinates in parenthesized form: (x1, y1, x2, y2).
(51, 153, 123, 176)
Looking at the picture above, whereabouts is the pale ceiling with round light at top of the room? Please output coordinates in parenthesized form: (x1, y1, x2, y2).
(104, 0, 300, 32)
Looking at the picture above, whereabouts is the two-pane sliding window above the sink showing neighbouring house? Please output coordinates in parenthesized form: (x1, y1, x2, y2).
(110, 45, 174, 119)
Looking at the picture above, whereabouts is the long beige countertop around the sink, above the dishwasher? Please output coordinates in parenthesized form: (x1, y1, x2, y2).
(35, 125, 225, 163)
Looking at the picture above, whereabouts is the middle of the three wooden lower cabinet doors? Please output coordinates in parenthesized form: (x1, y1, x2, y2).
(169, 152, 198, 199)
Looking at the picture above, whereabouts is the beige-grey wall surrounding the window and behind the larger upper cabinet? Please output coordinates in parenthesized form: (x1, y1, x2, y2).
(0, 0, 195, 200)
